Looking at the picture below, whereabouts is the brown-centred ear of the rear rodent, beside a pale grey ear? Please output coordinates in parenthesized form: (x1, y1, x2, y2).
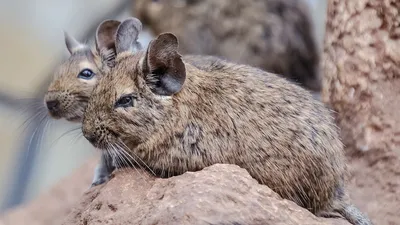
(95, 20, 121, 52)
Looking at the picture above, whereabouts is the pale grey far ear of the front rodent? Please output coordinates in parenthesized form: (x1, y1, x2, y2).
(115, 17, 142, 54)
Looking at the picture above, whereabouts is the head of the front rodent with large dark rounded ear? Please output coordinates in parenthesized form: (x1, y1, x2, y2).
(82, 20, 186, 149)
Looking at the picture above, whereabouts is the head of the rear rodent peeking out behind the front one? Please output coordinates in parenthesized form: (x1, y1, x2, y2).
(44, 20, 120, 121)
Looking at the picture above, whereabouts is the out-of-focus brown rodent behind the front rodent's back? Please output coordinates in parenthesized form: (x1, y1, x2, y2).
(133, 0, 322, 92)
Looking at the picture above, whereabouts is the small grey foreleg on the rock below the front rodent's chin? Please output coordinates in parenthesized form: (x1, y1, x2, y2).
(91, 153, 115, 187)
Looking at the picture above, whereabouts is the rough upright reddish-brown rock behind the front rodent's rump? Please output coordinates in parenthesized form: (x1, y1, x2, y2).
(322, 0, 400, 225)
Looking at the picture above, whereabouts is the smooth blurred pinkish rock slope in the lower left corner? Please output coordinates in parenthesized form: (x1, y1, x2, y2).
(0, 157, 99, 225)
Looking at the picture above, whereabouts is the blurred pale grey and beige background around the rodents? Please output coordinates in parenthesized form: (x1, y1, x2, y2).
(0, 0, 326, 212)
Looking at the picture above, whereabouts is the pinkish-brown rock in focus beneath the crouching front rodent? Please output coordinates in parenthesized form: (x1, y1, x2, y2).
(63, 164, 349, 225)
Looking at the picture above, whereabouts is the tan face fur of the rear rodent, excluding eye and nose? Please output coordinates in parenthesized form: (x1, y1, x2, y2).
(45, 46, 115, 122)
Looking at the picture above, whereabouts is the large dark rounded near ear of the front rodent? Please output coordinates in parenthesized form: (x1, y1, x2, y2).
(144, 33, 186, 96)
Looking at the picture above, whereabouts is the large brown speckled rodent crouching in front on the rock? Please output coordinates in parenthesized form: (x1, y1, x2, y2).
(82, 20, 371, 224)
